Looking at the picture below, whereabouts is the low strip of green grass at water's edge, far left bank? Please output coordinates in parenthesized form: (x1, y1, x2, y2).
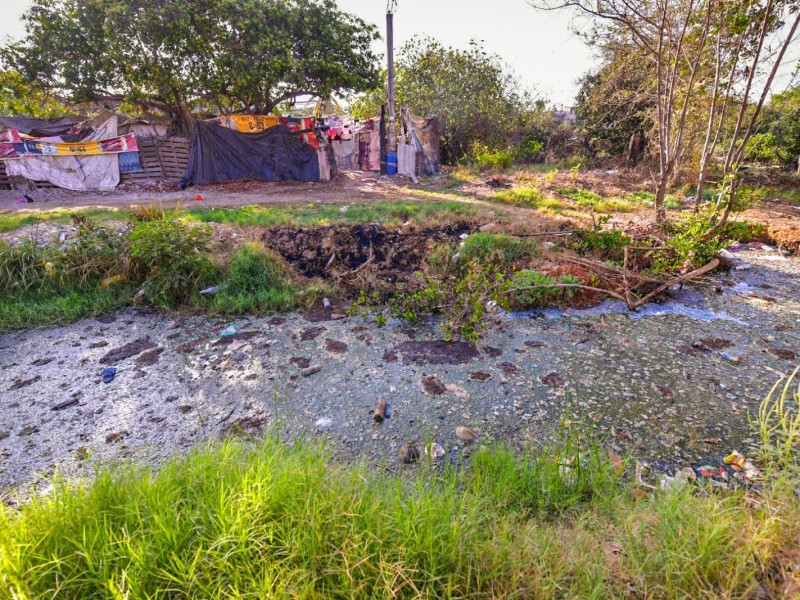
(0, 285, 133, 333)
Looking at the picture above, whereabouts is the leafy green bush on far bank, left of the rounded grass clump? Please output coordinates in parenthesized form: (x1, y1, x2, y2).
(130, 217, 213, 307)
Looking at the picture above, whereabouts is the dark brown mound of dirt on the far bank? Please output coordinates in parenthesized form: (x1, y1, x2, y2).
(262, 222, 475, 283)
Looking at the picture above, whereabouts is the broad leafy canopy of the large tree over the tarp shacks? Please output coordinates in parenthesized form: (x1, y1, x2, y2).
(2, 0, 378, 127)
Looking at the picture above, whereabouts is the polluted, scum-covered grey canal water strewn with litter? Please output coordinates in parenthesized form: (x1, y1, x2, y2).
(0, 252, 800, 492)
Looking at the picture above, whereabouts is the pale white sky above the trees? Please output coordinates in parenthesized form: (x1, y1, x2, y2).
(0, 0, 596, 108)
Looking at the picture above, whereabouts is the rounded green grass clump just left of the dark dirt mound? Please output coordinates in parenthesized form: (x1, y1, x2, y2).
(211, 242, 298, 314)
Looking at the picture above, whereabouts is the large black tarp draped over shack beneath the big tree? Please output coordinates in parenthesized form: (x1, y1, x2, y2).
(181, 122, 319, 188)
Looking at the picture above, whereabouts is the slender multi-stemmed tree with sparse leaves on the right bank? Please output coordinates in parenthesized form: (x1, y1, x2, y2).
(532, 0, 800, 225)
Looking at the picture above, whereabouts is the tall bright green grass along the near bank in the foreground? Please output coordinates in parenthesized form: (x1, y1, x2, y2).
(0, 438, 800, 600)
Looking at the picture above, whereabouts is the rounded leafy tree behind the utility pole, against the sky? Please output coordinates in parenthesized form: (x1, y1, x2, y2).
(352, 37, 533, 162)
